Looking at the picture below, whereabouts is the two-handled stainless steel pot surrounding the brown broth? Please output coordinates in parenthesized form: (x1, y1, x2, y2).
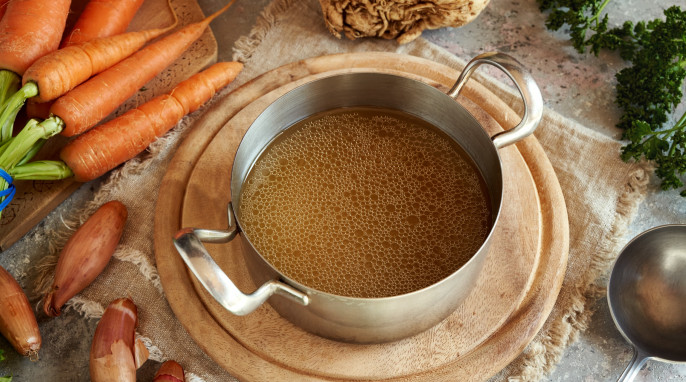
(174, 53, 543, 343)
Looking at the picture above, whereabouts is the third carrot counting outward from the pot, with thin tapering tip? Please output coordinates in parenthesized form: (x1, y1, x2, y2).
(22, 23, 176, 102)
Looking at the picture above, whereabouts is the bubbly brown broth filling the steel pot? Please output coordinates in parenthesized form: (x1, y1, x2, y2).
(239, 107, 491, 297)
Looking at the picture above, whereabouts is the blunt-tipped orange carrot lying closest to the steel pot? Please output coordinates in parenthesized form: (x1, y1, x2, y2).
(60, 62, 243, 182)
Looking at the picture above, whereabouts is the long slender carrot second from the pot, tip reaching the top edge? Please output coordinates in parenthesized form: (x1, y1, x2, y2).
(50, 0, 235, 137)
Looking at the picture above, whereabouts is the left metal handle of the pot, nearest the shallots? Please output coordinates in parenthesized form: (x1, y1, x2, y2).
(174, 203, 309, 316)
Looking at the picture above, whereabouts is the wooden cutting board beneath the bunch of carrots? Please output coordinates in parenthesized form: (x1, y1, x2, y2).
(0, 0, 217, 250)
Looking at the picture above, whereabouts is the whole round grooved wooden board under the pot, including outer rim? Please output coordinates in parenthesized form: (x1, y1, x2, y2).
(155, 54, 568, 380)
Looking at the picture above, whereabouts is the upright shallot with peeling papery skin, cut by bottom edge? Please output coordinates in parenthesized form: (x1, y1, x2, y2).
(90, 298, 148, 382)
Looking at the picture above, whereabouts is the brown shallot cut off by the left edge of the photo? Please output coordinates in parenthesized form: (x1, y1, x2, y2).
(0, 267, 41, 360)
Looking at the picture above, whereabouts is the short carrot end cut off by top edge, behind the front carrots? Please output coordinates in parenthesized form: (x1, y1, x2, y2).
(60, 0, 143, 48)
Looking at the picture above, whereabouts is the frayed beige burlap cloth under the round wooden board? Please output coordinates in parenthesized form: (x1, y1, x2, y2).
(5, 0, 649, 381)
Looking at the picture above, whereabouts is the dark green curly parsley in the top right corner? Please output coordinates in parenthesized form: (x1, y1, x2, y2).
(538, 0, 686, 197)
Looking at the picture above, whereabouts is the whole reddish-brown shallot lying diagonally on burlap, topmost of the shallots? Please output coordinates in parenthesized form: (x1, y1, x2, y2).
(43, 200, 128, 317)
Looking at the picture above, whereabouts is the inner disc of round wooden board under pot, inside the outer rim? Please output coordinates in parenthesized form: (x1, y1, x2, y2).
(181, 68, 540, 379)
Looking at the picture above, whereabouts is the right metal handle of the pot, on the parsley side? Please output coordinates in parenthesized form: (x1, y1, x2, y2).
(448, 52, 543, 148)
